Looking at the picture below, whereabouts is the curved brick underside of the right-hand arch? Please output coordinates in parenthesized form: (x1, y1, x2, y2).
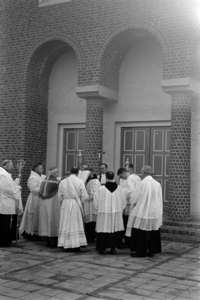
(97, 24, 170, 90)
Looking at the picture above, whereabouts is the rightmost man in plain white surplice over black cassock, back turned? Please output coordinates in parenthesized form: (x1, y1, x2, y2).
(126, 166, 163, 257)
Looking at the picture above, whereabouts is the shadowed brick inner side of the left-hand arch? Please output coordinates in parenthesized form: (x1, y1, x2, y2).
(21, 38, 78, 199)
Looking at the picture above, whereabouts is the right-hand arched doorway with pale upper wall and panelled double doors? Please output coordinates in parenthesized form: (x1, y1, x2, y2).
(97, 29, 171, 211)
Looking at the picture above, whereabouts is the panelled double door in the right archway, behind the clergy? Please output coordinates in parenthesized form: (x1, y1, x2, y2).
(121, 126, 170, 206)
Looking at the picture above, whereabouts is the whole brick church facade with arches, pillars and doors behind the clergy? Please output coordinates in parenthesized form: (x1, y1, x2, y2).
(0, 0, 200, 221)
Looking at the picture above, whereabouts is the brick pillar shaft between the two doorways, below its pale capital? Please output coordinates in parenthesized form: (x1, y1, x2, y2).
(85, 97, 103, 172)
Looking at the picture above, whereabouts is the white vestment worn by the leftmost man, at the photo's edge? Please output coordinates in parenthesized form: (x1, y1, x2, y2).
(0, 167, 23, 215)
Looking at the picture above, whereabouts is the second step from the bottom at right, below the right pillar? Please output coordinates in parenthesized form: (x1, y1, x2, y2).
(161, 225, 200, 240)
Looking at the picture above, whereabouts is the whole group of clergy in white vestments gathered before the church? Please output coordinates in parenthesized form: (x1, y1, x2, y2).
(0, 160, 163, 257)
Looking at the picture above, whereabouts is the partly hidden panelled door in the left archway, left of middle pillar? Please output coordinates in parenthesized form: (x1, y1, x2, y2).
(62, 128, 85, 176)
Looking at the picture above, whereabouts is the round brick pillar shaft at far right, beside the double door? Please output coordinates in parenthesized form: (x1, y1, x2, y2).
(169, 91, 191, 221)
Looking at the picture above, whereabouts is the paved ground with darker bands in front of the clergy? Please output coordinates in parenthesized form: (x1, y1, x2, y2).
(0, 239, 200, 300)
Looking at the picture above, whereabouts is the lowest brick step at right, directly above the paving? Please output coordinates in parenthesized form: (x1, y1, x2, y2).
(161, 233, 200, 244)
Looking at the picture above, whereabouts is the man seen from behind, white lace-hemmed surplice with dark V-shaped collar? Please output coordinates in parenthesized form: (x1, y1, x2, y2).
(94, 171, 126, 254)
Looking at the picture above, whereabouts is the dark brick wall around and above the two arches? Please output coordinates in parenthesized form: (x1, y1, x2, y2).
(0, 0, 199, 204)
